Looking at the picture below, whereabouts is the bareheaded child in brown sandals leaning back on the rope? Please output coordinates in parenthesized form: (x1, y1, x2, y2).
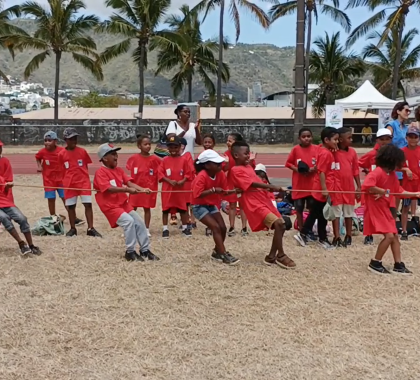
(230, 141, 296, 269)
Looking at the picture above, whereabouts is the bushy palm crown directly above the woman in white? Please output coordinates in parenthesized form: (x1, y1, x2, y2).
(155, 5, 230, 102)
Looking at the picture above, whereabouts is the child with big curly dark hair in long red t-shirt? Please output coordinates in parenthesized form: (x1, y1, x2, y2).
(362, 144, 420, 275)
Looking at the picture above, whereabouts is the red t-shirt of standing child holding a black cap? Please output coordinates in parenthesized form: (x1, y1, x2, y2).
(286, 145, 319, 200)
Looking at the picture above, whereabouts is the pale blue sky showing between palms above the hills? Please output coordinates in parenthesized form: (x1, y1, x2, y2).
(5, 0, 420, 52)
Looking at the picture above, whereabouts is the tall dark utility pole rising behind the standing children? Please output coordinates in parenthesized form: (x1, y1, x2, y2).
(293, 0, 306, 143)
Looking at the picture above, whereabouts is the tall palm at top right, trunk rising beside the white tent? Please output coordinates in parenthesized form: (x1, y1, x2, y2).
(346, 0, 420, 99)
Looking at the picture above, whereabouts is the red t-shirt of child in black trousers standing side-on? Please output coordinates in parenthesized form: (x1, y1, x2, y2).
(312, 146, 338, 205)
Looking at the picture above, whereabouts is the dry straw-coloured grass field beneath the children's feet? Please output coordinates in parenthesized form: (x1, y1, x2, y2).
(0, 176, 420, 380)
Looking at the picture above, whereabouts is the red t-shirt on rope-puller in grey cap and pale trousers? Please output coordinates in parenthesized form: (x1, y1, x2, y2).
(93, 166, 133, 228)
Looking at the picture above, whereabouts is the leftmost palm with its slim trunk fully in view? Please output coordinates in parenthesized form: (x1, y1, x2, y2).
(7, 0, 103, 123)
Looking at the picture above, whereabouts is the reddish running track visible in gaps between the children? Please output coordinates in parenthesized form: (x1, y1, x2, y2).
(5, 153, 292, 178)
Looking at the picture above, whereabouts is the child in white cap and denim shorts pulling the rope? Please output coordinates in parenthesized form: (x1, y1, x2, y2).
(192, 149, 239, 265)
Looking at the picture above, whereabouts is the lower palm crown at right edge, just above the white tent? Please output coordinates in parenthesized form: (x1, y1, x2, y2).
(362, 29, 420, 98)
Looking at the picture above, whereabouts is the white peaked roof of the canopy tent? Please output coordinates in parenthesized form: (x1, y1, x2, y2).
(335, 80, 397, 109)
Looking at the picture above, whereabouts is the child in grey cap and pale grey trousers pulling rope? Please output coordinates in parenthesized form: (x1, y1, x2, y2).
(93, 144, 159, 261)
